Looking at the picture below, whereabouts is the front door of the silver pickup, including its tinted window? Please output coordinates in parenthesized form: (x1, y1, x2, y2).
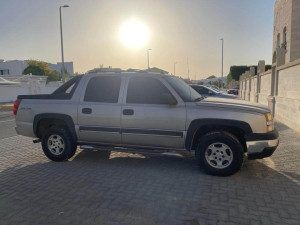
(121, 75, 186, 149)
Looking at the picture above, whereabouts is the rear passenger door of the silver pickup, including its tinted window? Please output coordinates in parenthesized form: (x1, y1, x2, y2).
(78, 74, 122, 144)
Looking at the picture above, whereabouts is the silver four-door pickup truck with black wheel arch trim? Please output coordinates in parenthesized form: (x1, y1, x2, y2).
(14, 72, 279, 176)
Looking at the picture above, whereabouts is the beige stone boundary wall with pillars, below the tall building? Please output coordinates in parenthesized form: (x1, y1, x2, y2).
(239, 59, 300, 131)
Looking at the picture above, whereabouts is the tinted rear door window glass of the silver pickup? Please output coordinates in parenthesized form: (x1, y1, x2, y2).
(84, 76, 121, 103)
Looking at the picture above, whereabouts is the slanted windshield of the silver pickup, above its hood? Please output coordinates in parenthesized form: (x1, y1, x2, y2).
(166, 76, 202, 102)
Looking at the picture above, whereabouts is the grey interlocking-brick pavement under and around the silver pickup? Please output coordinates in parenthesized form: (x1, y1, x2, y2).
(0, 111, 300, 225)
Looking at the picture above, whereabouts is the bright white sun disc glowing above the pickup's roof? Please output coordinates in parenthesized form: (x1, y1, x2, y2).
(119, 20, 149, 48)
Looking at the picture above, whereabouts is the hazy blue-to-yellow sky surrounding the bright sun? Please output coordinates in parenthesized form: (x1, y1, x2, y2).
(0, 0, 275, 79)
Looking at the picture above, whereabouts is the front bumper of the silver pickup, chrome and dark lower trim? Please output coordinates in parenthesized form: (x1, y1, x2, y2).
(246, 130, 279, 159)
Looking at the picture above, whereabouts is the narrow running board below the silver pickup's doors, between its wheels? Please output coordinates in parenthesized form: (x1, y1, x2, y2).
(80, 145, 182, 157)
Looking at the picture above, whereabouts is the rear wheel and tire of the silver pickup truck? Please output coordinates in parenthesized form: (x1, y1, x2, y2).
(42, 128, 76, 161)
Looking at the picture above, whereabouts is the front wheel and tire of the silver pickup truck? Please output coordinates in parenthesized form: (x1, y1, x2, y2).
(195, 131, 244, 176)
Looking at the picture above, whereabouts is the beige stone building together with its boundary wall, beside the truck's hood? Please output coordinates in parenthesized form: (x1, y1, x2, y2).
(239, 0, 300, 132)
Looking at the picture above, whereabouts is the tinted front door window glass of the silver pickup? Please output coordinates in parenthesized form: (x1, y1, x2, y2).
(126, 77, 171, 104)
